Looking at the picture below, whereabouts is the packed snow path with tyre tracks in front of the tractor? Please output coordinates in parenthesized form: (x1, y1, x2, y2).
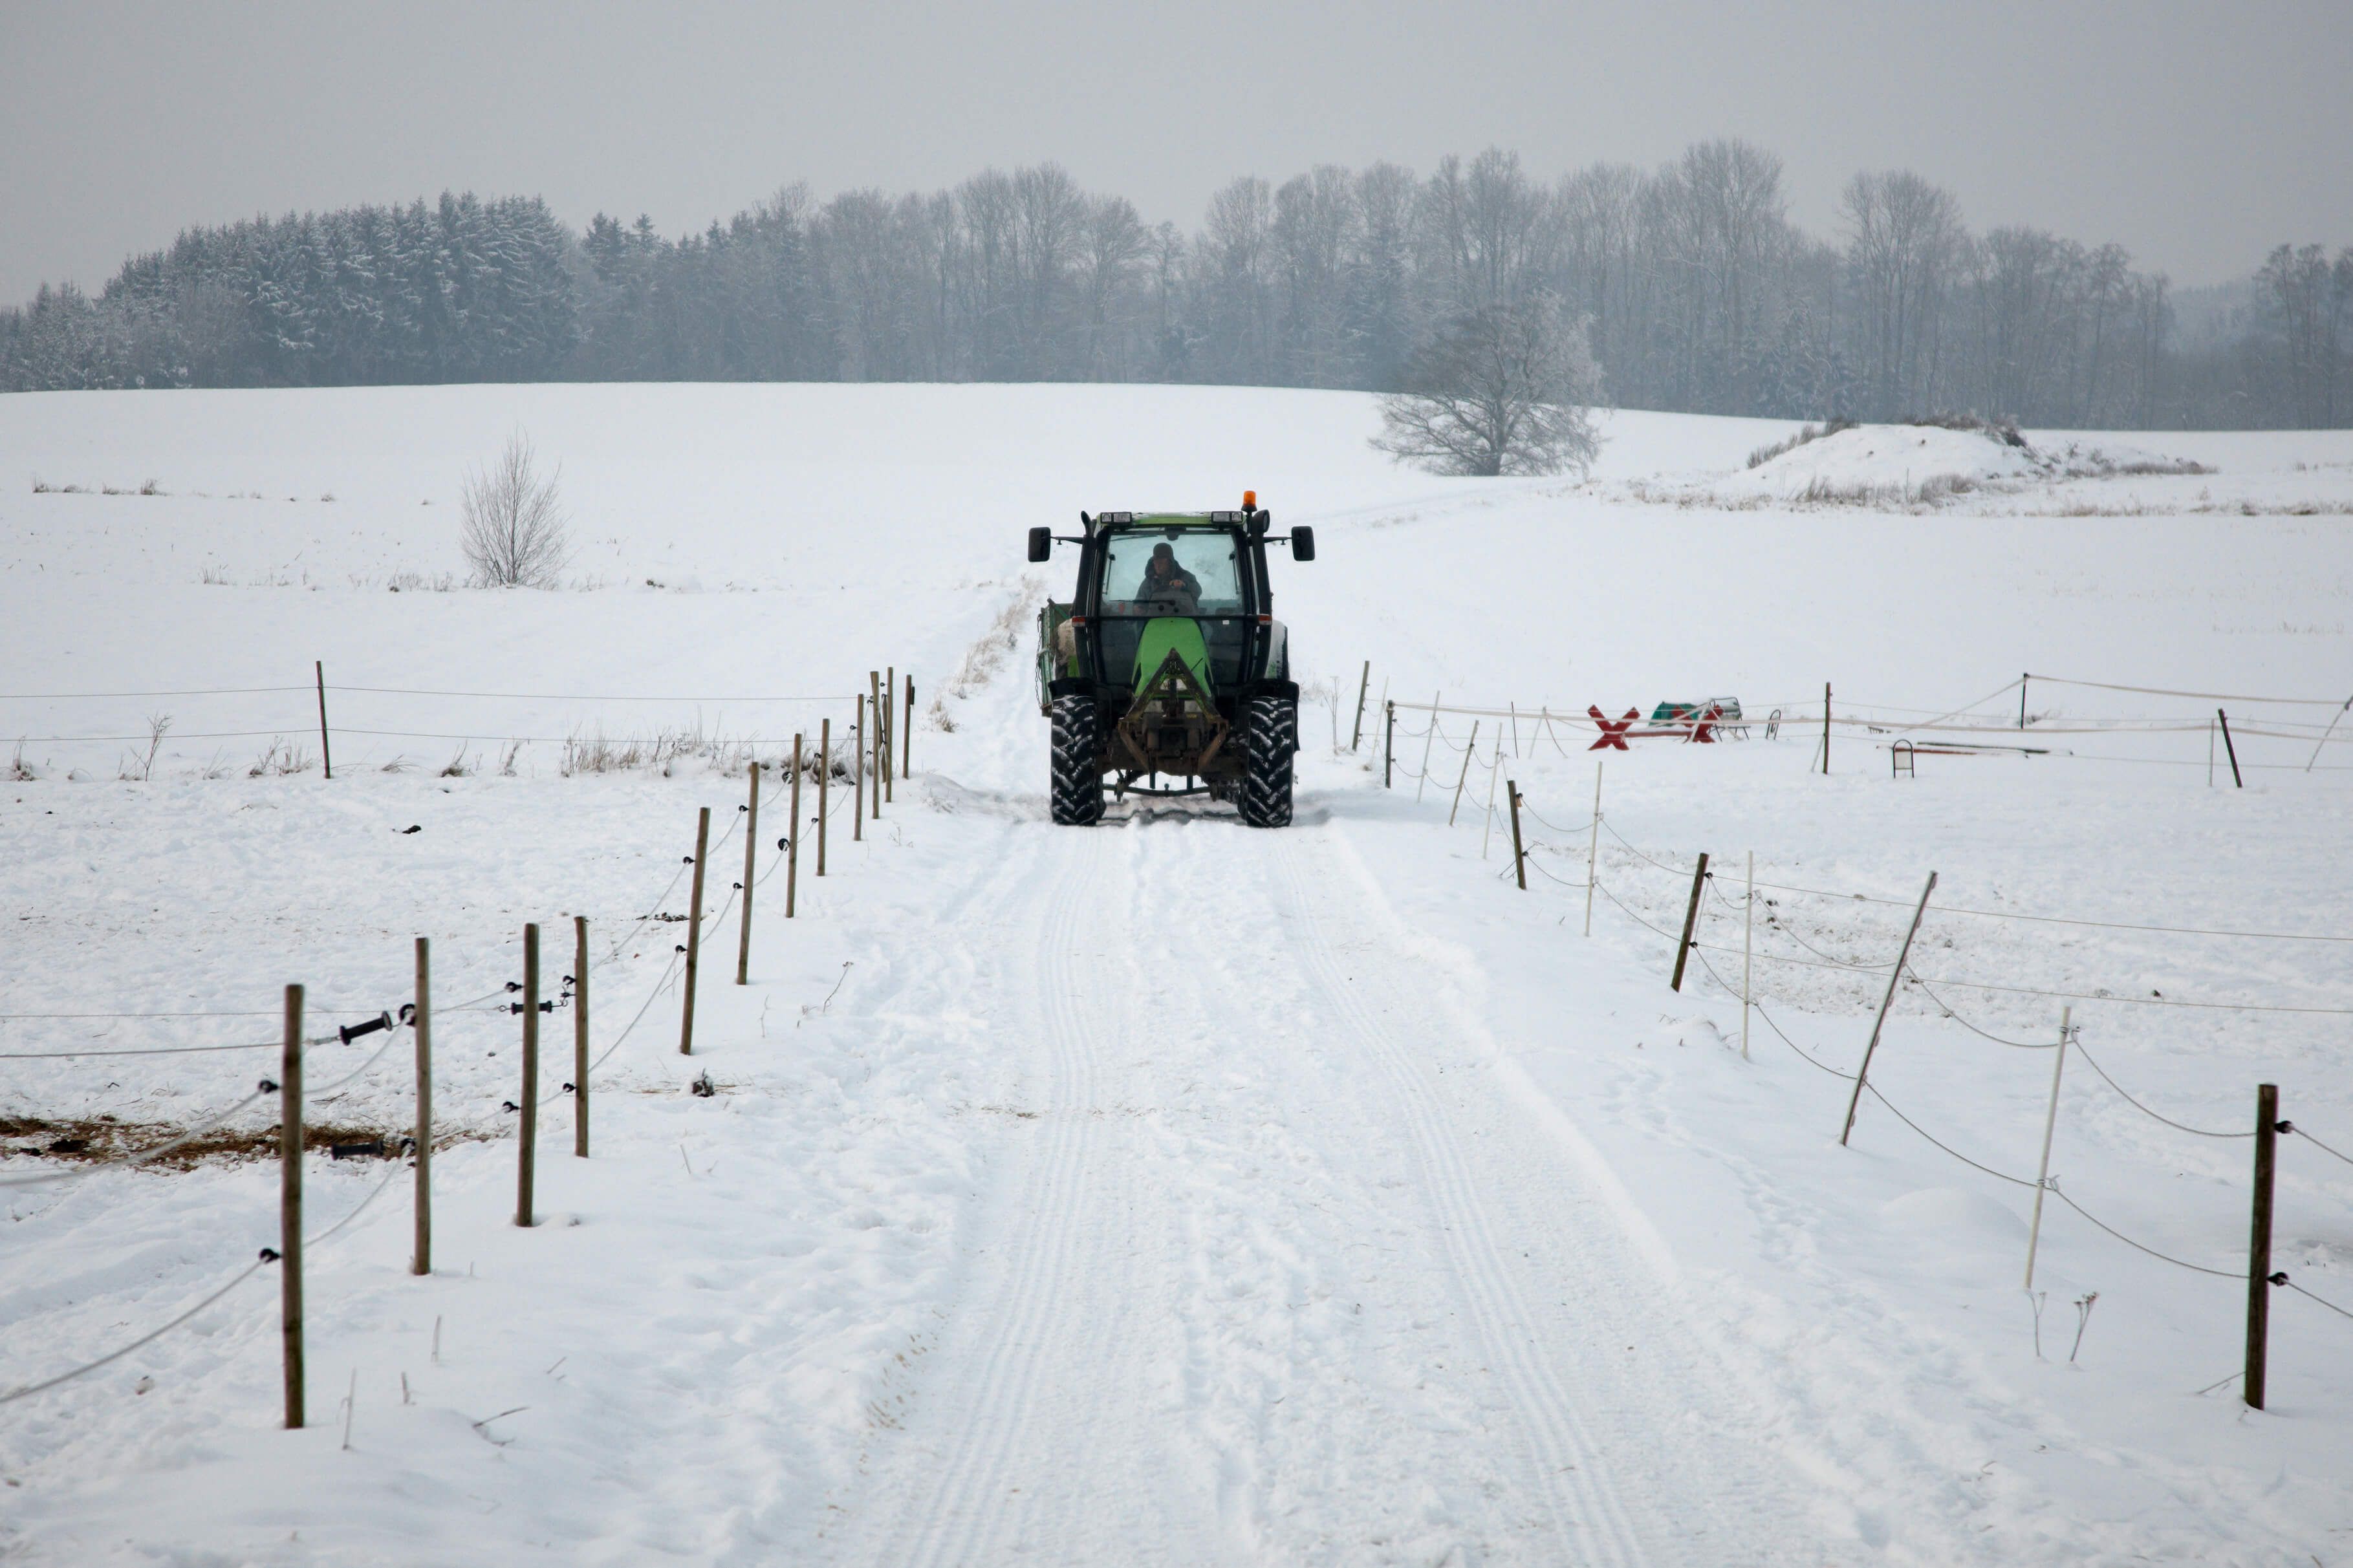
(826, 813, 1819, 1563)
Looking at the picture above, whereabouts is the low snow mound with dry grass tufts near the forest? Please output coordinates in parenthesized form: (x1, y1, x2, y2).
(1715, 425, 2205, 506)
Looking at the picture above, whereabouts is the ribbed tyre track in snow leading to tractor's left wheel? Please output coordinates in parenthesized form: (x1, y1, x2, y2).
(835, 828, 1224, 1565)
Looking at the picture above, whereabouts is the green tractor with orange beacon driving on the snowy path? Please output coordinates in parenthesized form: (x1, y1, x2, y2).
(1030, 491, 1316, 828)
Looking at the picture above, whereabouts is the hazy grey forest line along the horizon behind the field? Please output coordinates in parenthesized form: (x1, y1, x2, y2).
(0, 141, 2353, 428)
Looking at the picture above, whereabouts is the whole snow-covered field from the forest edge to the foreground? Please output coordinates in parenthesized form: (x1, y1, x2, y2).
(0, 385, 2353, 1563)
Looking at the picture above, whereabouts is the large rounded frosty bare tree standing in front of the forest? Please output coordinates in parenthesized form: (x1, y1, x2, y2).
(1372, 294, 1600, 475)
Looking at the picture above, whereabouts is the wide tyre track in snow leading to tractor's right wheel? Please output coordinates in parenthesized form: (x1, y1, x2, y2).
(1285, 828, 1856, 1568)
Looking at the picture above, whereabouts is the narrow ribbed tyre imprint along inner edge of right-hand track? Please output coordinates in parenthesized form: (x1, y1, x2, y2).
(1280, 842, 1649, 1568)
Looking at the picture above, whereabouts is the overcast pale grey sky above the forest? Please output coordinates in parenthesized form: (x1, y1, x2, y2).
(0, 0, 2353, 301)
